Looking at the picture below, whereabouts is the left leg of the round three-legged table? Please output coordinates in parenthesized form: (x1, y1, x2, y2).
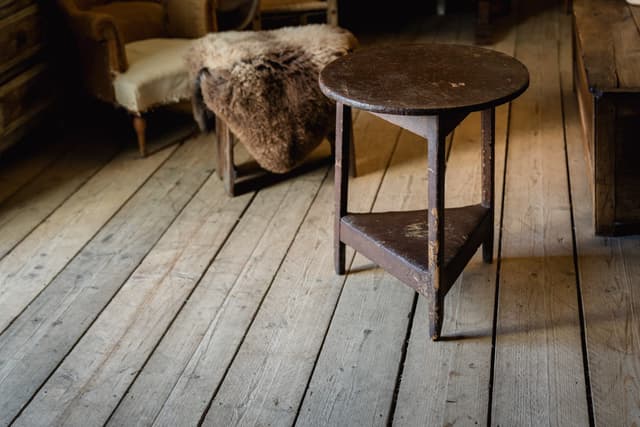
(334, 103, 352, 274)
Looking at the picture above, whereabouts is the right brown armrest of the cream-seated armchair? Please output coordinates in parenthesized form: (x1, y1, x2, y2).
(166, 0, 218, 38)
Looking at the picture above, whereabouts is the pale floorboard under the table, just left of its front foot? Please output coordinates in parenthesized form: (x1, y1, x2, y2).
(296, 14, 461, 426)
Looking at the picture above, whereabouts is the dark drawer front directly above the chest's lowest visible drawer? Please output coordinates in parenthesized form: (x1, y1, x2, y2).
(0, 4, 42, 75)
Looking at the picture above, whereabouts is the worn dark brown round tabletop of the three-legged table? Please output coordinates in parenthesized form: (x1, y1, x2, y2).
(320, 43, 529, 115)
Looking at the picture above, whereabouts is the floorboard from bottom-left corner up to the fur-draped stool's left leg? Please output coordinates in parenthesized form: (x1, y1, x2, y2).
(0, 135, 213, 425)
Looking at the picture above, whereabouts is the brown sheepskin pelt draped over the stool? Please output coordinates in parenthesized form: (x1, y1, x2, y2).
(186, 24, 357, 173)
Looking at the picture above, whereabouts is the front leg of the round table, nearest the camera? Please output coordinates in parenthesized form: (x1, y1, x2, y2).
(427, 116, 446, 341)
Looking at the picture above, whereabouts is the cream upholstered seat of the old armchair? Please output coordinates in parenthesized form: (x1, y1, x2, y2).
(113, 39, 193, 113)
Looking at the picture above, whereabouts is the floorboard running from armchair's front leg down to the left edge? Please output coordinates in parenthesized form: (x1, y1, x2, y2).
(0, 142, 176, 331)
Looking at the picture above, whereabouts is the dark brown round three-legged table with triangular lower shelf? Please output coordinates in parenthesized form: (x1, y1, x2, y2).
(320, 44, 529, 340)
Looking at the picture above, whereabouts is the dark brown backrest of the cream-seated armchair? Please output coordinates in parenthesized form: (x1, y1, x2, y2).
(91, 1, 167, 43)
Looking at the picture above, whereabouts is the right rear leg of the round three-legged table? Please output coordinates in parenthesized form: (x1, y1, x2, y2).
(482, 108, 496, 263)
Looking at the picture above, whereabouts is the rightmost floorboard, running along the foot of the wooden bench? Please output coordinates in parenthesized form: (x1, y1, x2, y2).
(560, 11, 640, 426)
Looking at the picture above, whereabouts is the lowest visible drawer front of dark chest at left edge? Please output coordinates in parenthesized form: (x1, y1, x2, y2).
(0, 64, 52, 136)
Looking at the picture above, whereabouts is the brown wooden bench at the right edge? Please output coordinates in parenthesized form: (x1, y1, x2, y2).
(573, 0, 640, 235)
